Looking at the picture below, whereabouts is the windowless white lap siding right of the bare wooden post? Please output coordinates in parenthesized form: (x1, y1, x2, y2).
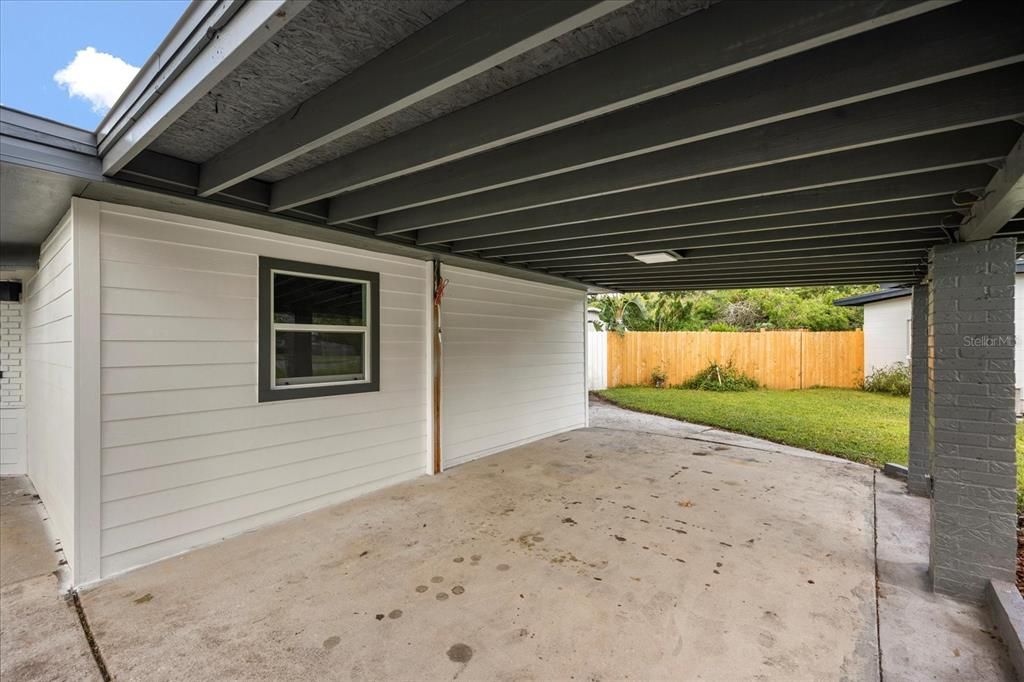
(441, 266, 587, 468)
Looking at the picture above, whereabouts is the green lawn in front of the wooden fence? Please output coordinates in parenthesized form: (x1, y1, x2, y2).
(598, 387, 1024, 502)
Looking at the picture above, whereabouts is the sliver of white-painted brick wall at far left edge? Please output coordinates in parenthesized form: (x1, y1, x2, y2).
(0, 296, 28, 475)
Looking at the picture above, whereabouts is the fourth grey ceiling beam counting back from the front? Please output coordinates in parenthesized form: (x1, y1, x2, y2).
(374, 65, 1024, 235)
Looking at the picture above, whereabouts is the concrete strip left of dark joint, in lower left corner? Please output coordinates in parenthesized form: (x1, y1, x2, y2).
(0, 476, 101, 682)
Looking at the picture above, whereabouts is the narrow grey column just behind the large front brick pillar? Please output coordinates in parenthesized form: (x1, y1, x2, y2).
(906, 285, 931, 497)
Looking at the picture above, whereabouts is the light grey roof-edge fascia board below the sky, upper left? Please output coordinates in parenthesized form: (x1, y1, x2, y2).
(99, 0, 310, 175)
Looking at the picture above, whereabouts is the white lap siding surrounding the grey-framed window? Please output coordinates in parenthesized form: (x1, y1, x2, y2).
(100, 205, 429, 577)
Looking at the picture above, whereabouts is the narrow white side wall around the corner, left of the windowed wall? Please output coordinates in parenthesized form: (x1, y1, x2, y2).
(22, 214, 75, 557)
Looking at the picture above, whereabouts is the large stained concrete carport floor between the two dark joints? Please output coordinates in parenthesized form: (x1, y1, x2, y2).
(82, 401, 879, 680)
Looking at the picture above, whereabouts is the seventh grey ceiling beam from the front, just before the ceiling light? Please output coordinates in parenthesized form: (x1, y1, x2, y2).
(480, 195, 956, 259)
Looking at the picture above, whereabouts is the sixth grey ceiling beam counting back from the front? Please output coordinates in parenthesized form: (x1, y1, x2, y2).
(452, 165, 992, 255)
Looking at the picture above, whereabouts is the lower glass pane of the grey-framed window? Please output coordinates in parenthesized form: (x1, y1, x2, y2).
(274, 332, 367, 386)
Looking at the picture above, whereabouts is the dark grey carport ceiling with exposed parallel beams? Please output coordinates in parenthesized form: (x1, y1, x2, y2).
(99, 0, 1024, 290)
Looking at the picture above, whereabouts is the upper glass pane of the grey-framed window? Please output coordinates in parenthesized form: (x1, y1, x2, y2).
(273, 272, 367, 327)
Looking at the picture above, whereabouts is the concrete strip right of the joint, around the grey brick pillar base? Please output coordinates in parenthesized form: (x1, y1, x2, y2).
(877, 476, 1016, 682)
